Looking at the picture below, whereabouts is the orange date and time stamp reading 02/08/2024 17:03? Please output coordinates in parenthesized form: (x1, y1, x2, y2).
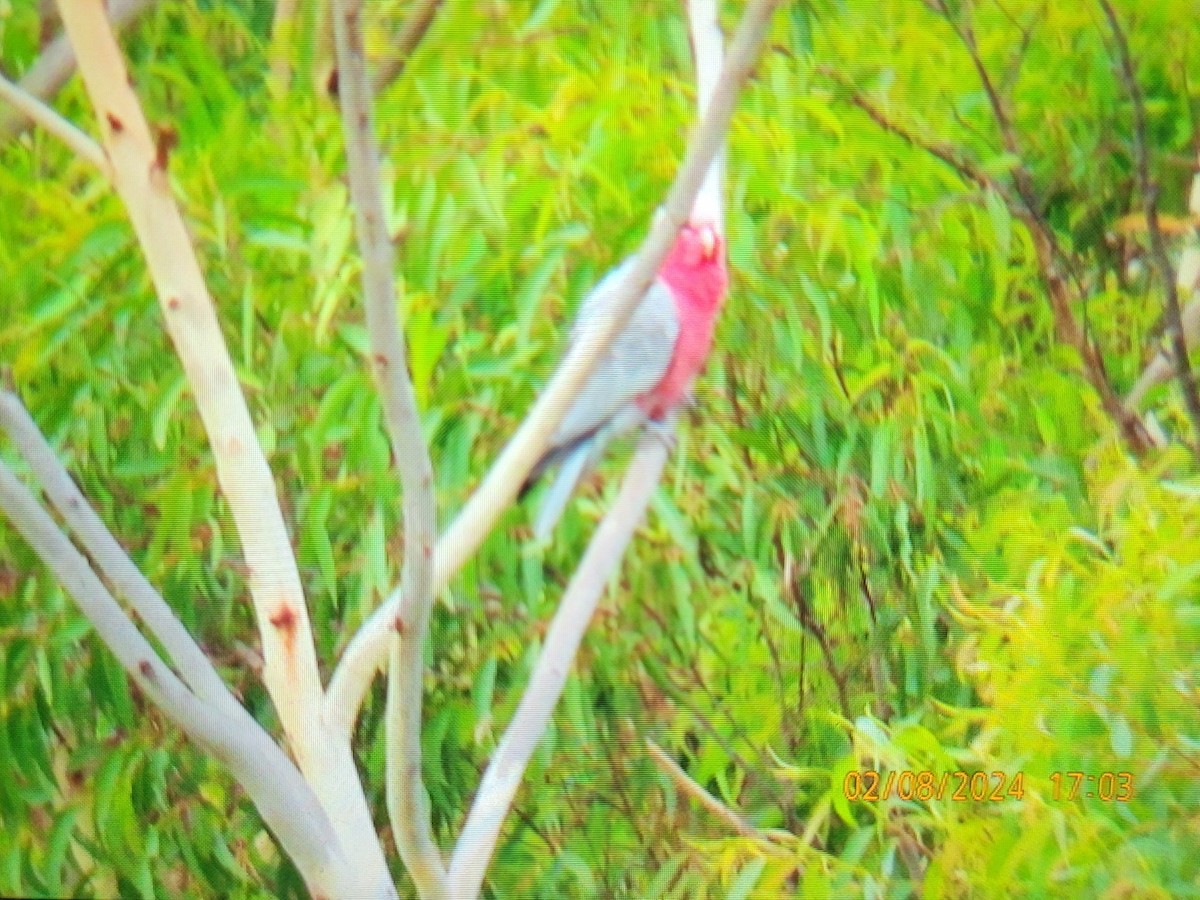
(842, 769, 1134, 803)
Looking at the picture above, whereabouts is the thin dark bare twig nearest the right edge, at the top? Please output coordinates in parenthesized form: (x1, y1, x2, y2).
(1099, 0, 1200, 458)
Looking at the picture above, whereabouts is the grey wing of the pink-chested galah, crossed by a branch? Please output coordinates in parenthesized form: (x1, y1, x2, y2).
(551, 259, 679, 446)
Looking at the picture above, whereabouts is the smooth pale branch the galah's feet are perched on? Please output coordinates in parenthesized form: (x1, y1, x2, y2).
(450, 421, 674, 899)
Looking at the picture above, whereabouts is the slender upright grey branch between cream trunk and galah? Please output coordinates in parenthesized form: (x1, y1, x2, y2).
(332, 0, 446, 898)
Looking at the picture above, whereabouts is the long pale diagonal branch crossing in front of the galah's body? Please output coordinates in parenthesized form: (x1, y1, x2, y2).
(326, 0, 781, 714)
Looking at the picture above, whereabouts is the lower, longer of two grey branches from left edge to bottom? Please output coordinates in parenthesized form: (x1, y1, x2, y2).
(0, 461, 366, 898)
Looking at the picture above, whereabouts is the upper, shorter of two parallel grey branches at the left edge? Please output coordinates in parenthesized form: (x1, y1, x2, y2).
(0, 385, 238, 716)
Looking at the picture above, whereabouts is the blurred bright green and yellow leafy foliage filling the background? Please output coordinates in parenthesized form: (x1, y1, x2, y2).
(0, 0, 1200, 898)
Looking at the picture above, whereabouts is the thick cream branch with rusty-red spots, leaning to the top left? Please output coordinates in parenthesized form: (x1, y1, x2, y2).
(51, 0, 395, 896)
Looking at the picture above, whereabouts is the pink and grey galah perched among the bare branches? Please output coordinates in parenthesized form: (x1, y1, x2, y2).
(526, 222, 728, 540)
